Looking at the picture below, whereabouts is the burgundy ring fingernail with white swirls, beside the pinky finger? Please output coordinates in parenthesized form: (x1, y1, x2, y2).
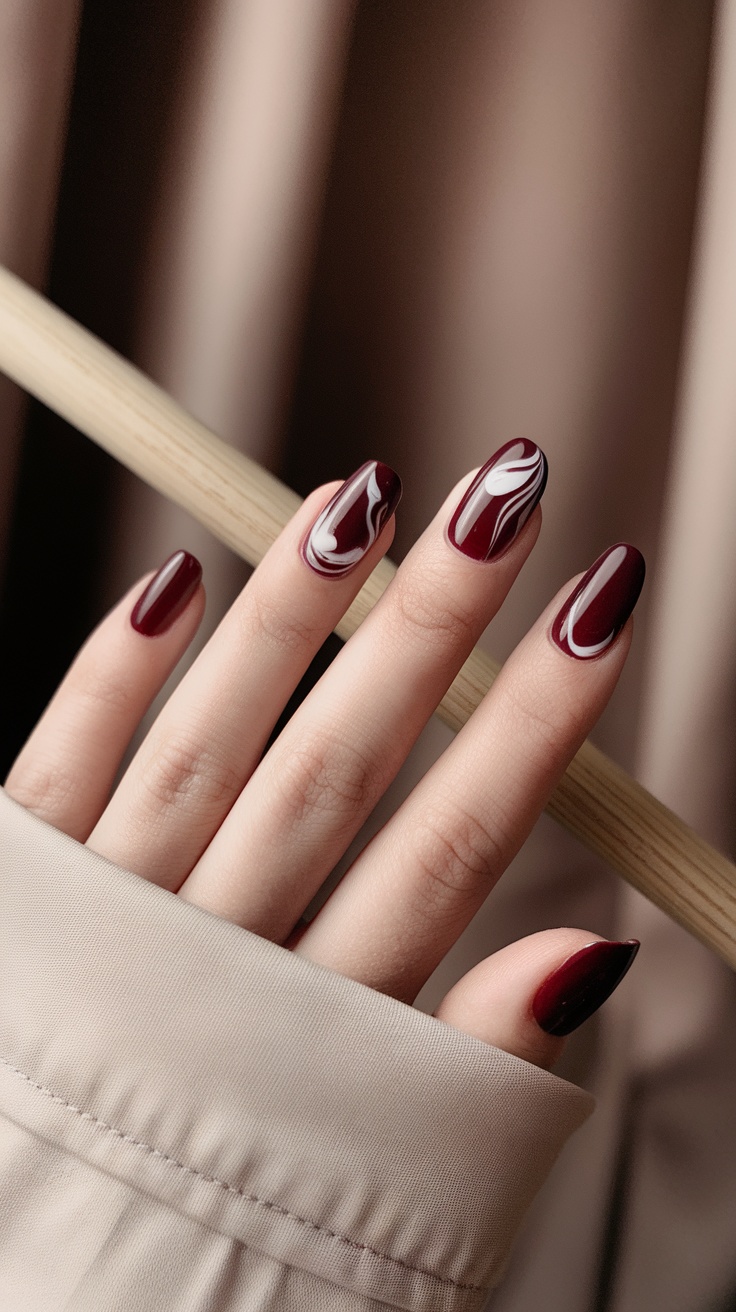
(302, 461, 401, 579)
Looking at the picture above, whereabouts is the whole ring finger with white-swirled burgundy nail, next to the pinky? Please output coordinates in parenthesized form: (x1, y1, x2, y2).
(88, 461, 401, 890)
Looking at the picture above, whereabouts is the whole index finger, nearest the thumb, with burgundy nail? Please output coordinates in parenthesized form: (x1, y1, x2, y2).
(287, 543, 644, 1002)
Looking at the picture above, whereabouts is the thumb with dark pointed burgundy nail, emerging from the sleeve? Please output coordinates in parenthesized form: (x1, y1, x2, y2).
(434, 929, 639, 1071)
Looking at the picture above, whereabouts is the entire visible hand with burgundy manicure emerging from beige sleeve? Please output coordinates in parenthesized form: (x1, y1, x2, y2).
(5, 441, 644, 1067)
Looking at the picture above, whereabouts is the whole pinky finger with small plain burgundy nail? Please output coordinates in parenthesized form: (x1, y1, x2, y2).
(4, 551, 205, 842)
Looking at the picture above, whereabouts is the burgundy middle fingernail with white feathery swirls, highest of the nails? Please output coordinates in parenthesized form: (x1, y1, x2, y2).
(447, 437, 547, 560)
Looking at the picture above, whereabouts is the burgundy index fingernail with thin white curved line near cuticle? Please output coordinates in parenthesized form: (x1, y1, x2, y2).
(551, 542, 645, 660)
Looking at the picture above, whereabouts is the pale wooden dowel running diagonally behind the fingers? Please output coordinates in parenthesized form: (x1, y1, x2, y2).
(0, 269, 736, 966)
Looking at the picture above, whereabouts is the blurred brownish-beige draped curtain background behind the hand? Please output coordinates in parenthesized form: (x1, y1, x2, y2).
(0, 0, 736, 1312)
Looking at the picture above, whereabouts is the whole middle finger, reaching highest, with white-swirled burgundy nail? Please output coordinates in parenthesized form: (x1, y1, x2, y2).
(180, 440, 547, 942)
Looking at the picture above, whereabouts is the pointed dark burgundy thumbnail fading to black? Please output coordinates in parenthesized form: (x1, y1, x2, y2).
(531, 938, 639, 1035)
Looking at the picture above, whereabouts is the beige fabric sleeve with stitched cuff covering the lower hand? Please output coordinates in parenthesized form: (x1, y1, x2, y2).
(0, 790, 593, 1312)
